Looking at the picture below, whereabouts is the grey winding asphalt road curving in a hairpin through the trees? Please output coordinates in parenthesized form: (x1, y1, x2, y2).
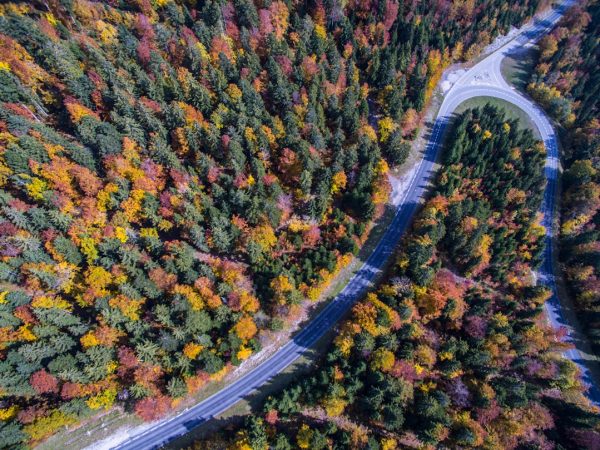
(110, 0, 600, 450)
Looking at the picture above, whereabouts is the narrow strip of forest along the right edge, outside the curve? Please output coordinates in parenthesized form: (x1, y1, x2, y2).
(528, 1, 600, 354)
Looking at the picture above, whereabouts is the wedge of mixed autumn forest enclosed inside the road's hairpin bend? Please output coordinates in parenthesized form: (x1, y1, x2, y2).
(194, 105, 600, 450)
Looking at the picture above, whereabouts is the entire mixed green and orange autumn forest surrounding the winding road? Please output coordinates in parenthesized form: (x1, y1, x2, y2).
(0, 0, 600, 450)
